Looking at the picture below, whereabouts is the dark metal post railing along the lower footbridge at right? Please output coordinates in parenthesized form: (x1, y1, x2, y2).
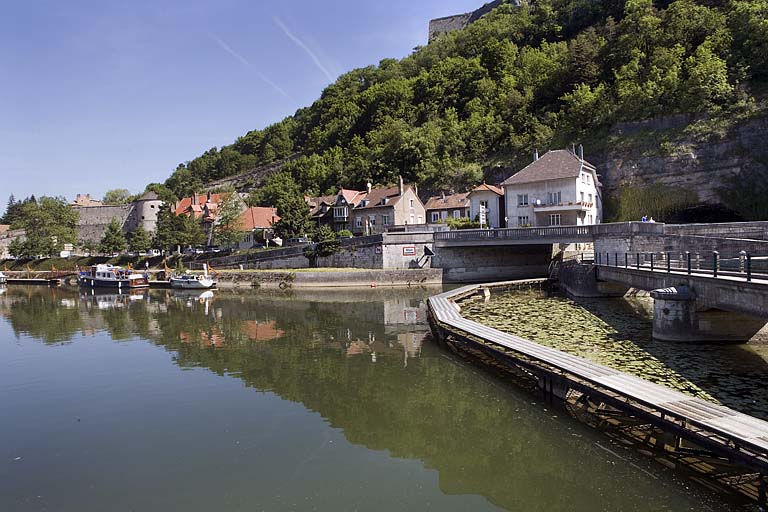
(594, 251, 768, 281)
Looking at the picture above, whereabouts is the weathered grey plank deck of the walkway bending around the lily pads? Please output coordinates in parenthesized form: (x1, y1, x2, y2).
(429, 285, 768, 475)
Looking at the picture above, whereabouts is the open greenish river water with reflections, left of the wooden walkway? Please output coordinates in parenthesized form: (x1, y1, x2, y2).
(0, 287, 736, 512)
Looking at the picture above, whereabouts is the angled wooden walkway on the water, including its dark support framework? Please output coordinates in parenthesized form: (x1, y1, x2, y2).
(429, 283, 768, 510)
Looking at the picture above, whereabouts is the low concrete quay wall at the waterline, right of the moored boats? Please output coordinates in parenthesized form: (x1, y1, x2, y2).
(217, 269, 443, 288)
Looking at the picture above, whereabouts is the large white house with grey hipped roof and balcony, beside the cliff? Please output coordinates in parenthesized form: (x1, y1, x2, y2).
(502, 146, 603, 227)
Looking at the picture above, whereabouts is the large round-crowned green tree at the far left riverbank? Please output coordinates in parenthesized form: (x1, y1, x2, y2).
(11, 196, 79, 258)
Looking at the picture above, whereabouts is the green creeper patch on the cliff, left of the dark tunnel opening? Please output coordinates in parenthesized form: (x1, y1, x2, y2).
(606, 184, 699, 222)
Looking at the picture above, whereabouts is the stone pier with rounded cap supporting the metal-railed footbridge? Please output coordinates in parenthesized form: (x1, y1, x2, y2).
(651, 286, 765, 343)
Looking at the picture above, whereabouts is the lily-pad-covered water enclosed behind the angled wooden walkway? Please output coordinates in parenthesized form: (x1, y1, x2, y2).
(462, 291, 768, 419)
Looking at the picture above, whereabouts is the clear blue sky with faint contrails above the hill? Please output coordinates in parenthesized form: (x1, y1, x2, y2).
(0, 0, 483, 204)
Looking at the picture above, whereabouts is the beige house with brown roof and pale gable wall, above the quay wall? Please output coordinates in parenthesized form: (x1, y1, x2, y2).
(350, 177, 426, 235)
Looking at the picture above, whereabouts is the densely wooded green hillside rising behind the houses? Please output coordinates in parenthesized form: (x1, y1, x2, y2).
(159, 0, 768, 210)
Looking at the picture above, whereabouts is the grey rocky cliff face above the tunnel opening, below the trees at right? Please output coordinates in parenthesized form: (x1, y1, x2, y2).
(593, 116, 768, 206)
